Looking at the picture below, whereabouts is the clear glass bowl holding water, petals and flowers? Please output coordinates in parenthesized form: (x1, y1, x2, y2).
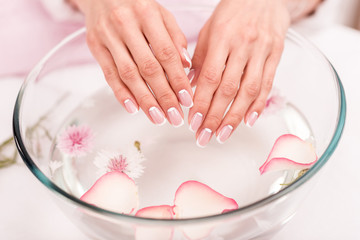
(13, 6, 346, 239)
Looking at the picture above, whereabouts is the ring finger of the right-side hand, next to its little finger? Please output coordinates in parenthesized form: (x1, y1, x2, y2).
(217, 54, 266, 142)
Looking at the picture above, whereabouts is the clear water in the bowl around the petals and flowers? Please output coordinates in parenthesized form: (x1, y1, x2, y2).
(51, 89, 314, 210)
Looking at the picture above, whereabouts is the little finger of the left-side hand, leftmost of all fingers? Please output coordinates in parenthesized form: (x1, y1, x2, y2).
(86, 36, 139, 114)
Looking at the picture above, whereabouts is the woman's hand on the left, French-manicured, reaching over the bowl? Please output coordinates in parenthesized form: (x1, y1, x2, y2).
(71, 0, 193, 127)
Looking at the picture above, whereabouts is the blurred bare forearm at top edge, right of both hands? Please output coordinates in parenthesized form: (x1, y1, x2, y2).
(283, 0, 324, 22)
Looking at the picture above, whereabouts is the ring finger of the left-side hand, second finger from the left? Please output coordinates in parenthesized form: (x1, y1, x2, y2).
(97, 30, 166, 125)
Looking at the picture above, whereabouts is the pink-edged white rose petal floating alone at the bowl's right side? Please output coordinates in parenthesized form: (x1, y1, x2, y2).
(259, 134, 317, 174)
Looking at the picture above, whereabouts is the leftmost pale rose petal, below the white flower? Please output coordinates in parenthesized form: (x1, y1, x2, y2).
(80, 171, 139, 214)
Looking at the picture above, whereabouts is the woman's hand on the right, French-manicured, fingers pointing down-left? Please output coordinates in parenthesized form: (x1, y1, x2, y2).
(189, 0, 290, 146)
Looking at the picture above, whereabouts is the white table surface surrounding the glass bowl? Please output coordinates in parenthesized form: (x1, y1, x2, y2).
(0, 25, 360, 240)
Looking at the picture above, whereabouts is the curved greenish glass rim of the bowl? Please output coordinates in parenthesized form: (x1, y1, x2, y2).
(13, 28, 346, 225)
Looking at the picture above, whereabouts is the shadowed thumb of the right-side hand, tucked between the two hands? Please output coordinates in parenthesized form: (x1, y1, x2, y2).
(188, 24, 208, 87)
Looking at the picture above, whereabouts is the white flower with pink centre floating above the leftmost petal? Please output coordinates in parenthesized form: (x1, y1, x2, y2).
(94, 149, 145, 179)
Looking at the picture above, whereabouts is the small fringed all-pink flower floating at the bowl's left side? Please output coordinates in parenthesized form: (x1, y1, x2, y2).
(57, 125, 93, 157)
